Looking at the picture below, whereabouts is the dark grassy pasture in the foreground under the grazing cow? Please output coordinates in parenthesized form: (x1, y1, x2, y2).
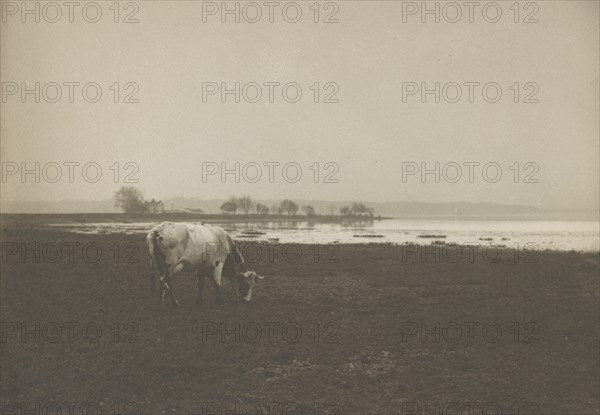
(0, 228, 600, 415)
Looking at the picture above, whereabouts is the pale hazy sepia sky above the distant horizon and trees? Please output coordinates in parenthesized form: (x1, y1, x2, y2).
(0, 1, 600, 209)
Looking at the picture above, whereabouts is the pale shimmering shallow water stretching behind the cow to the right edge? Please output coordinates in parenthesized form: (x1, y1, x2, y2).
(52, 219, 600, 251)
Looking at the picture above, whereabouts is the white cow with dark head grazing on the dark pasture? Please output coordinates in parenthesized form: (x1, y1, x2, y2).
(146, 222, 264, 306)
